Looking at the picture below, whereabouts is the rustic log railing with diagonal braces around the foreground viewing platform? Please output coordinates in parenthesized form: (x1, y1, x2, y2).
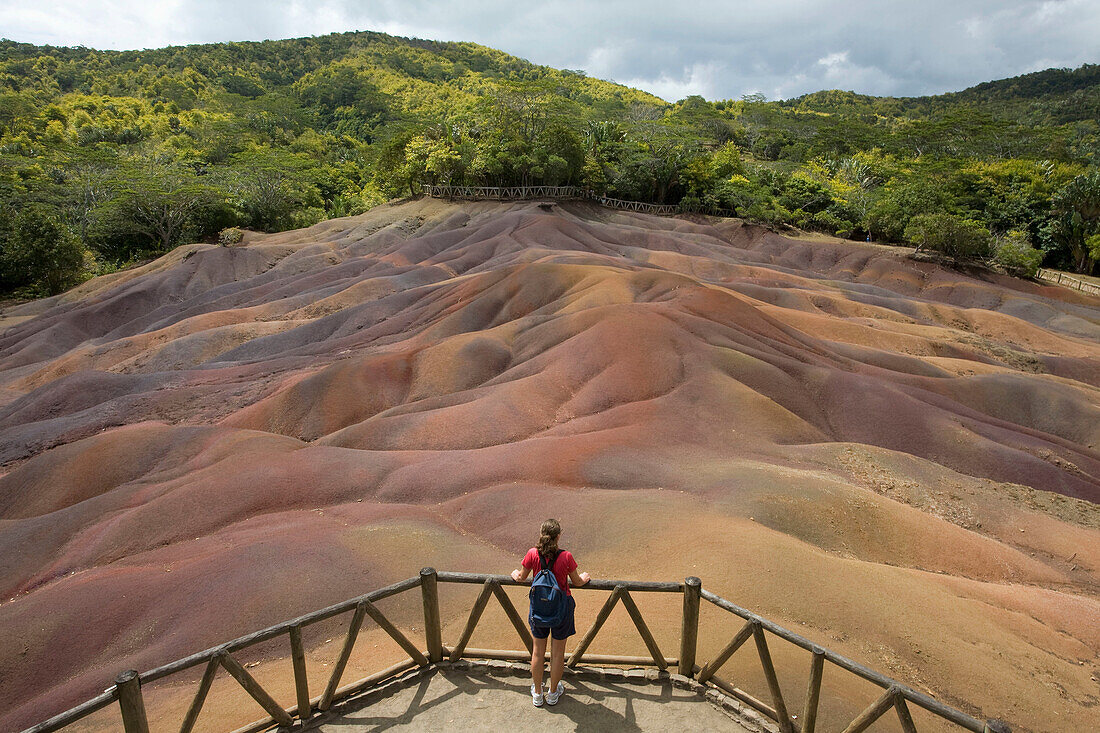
(24, 568, 1010, 733)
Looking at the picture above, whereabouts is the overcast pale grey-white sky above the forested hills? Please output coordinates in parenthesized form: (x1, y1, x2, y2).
(0, 0, 1100, 101)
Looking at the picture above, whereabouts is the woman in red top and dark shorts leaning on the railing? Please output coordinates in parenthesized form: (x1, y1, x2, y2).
(512, 519, 590, 707)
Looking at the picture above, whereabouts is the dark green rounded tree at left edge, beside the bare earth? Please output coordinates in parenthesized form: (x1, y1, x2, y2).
(0, 204, 84, 295)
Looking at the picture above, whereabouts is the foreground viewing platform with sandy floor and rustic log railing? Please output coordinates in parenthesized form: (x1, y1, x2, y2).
(24, 568, 1010, 733)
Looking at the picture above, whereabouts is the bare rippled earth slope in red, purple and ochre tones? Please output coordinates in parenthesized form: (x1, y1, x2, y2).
(0, 200, 1100, 731)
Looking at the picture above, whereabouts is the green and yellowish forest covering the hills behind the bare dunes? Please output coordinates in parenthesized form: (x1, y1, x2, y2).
(0, 32, 1100, 297)
